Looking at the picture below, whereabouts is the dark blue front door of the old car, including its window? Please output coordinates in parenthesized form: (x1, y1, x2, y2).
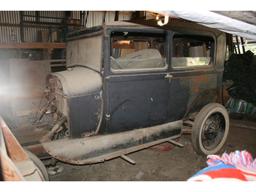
(104, 29, 171, 133)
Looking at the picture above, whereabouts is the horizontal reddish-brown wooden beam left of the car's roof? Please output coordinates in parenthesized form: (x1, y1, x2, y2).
(0, 42, 66, 49)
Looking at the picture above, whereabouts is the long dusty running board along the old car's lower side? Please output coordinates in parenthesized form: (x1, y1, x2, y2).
(42, 120, 182, 165)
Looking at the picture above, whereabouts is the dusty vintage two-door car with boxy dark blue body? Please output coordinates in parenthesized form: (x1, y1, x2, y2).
(42, 21, 229, 164)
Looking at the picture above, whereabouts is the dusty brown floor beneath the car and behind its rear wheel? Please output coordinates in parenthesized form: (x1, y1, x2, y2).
(47, 120, 256, 181)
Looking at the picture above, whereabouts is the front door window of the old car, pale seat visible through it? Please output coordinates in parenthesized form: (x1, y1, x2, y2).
(110, 32, 166, 70)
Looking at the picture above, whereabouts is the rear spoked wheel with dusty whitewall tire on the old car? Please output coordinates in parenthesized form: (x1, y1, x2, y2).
(191, 103, 229, 155)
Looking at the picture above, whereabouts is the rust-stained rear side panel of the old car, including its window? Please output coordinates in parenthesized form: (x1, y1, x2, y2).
(169, 31, 219, 121)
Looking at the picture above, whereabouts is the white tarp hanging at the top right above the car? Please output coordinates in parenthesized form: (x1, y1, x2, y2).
(158, 11, 256, 40)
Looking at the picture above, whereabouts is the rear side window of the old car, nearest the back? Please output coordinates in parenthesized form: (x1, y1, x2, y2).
(171, 34, 214, 68)
